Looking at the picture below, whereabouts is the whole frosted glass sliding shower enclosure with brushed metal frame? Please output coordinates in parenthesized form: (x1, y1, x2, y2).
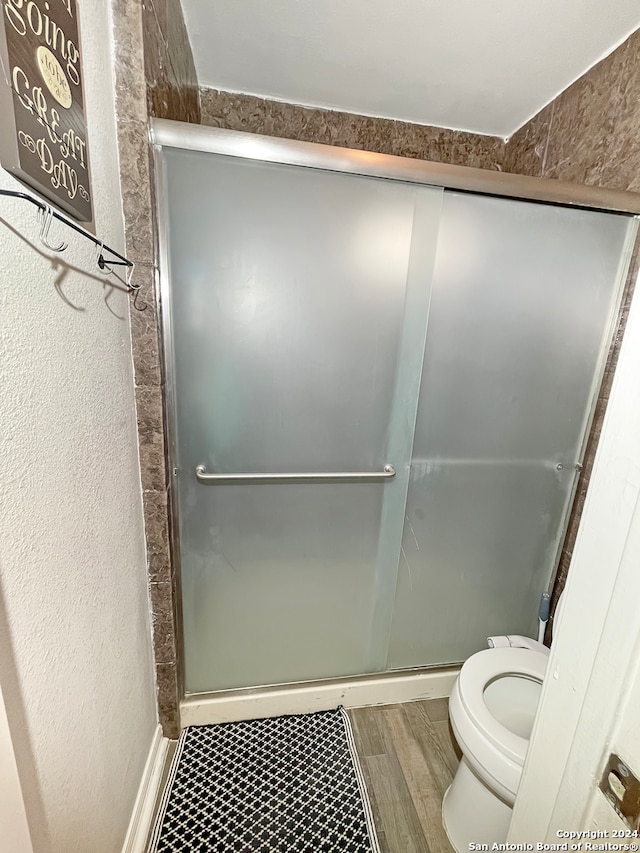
(154, 122, 637, 704)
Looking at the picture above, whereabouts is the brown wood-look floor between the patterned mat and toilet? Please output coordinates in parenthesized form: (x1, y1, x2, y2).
(349, 699, 460, 853)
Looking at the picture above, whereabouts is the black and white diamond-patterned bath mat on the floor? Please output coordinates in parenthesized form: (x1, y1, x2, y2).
(150, 708, 380, 853)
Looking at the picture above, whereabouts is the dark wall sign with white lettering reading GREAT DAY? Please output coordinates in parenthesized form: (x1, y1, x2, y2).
(0, 0, 93, 222)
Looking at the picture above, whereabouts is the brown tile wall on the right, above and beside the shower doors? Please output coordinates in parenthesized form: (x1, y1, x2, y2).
(503, 32, 640, 627)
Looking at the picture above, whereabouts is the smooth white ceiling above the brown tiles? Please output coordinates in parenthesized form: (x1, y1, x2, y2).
(182, 0, 640, 138)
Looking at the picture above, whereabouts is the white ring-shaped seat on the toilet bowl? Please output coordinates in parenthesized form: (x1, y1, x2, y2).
(458, 647, 549, 764)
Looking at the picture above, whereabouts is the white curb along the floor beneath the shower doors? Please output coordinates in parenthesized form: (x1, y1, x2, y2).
(180, 666, 460, 728)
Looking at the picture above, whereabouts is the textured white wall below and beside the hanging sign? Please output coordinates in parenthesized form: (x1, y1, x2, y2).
(0, 3, 156, 853)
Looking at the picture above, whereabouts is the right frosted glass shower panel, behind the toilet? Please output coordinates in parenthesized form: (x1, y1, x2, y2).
(388, 192, 630, 668)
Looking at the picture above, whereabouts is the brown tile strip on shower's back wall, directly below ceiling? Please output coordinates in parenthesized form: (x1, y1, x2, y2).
(200, 88, 504, 169)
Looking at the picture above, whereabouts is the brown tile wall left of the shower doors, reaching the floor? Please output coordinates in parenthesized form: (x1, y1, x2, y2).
(112, 0, 200, 737)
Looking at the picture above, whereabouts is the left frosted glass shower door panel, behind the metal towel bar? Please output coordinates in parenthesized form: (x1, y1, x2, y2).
(164, 150, 442, 692)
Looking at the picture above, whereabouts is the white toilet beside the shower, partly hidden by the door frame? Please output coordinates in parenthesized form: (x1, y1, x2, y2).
(442, 602, 560, 853)
